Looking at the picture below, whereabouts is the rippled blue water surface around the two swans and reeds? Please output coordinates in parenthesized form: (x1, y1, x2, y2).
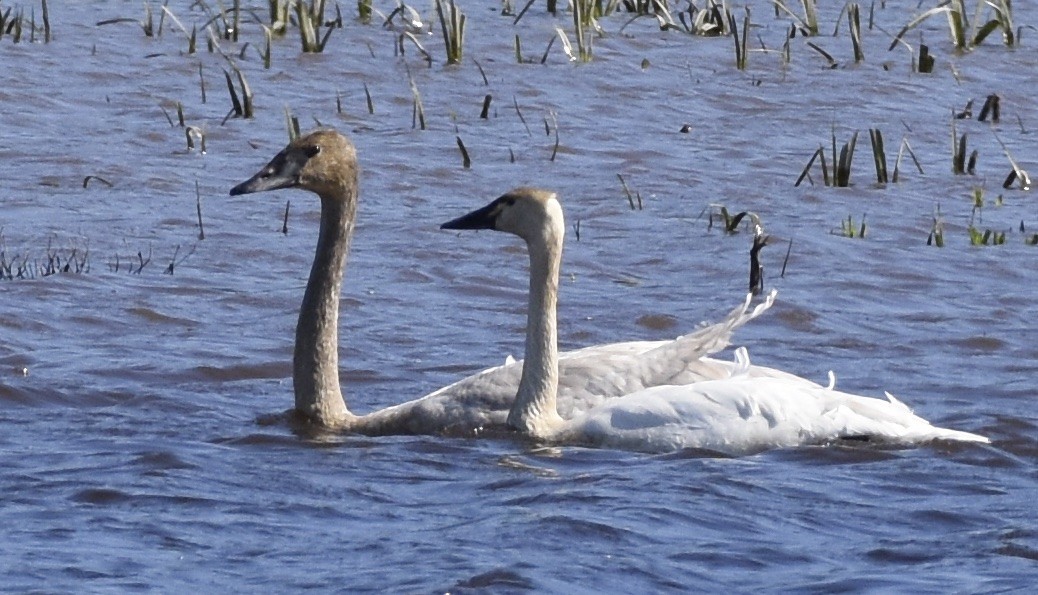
(0, 1, 1038, 592)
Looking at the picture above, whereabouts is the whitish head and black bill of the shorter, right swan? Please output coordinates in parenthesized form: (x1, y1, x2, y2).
(440, 187, 565, 243)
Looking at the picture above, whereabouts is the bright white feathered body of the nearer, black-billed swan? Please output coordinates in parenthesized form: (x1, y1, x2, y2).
(553, 375, 988, 455)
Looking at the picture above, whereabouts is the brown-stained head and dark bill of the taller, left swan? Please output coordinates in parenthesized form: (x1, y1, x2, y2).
(230, 129, 358, 198)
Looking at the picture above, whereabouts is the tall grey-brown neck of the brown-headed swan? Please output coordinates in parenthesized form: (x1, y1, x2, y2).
(292, 187, 357, 426)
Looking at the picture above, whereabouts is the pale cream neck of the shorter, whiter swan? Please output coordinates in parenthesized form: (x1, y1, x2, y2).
(508, 222, 563, 436)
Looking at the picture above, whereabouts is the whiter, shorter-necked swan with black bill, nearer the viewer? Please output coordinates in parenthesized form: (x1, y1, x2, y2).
(443, 188, 988, 455)
